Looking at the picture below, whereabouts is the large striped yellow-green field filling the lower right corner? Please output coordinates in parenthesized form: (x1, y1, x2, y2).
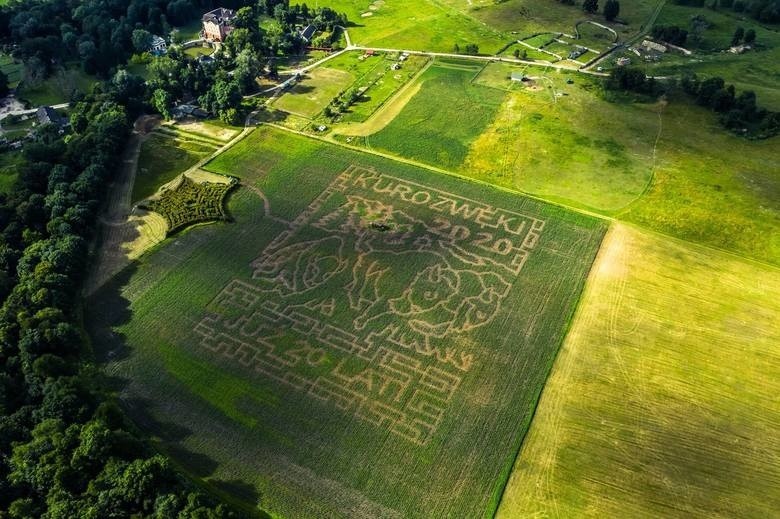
(498, 225, 780, 519)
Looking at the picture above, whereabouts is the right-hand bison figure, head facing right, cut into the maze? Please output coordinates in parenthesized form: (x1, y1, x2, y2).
(347, 250, 510, 338)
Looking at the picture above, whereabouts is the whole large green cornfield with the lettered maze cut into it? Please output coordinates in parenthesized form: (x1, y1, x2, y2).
(88, 127, 604, 517)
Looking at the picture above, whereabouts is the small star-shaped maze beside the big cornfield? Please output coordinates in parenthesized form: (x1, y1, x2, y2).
(142, 175, 238, 234)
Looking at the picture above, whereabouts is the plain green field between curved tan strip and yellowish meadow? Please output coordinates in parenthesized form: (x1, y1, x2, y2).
(368, 60, 504, 169)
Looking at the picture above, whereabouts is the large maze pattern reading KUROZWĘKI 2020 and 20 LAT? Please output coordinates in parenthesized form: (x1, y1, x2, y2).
(195, 167, 544, 445)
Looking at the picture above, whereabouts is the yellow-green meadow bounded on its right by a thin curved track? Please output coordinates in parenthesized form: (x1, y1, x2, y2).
(466, 63, 659, 214)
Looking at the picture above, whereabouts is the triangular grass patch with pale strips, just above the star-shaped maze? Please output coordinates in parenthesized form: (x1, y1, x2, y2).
(132, 126, 224, 202)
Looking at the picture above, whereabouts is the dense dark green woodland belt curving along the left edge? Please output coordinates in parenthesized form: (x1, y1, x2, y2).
(0, 73, 241, 519)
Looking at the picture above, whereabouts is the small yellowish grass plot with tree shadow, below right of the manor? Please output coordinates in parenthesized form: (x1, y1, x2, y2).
(273, 66, 355, 119)
